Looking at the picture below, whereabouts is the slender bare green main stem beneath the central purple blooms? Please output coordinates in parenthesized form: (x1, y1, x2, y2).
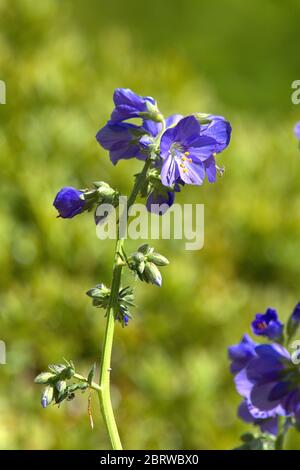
(98, 158, 151, 450)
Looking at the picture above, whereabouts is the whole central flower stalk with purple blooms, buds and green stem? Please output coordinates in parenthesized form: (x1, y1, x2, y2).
(35, 88, 231, 450)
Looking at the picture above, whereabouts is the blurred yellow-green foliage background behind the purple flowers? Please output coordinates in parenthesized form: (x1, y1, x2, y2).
(0, 0, 300, 449)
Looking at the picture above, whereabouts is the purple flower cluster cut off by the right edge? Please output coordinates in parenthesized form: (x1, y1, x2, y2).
(228, 304, 300, 435)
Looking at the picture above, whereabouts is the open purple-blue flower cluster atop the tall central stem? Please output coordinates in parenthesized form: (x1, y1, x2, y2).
(96, 88, 231, 212)
